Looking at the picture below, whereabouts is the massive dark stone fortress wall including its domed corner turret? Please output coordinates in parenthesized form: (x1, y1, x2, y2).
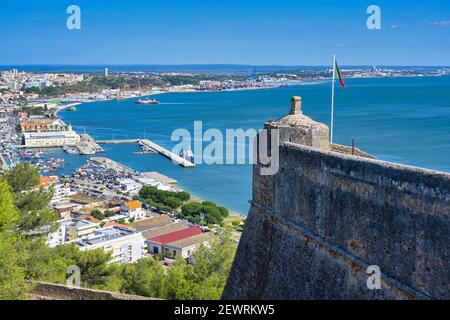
(223, 97, 450, 299)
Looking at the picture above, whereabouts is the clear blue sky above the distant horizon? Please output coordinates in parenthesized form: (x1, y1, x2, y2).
(0, 0, 450, 65)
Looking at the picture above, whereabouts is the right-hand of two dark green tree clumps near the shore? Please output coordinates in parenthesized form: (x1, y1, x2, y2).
(180, 201, 229, 224)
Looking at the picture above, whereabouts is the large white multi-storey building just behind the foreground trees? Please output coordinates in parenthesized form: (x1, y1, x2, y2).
(76, 226, 144, 263)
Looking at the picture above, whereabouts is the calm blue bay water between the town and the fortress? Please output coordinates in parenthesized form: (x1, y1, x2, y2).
(47, 77, 450, 215)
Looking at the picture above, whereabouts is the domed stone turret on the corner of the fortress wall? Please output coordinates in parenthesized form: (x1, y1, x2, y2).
(265, 97, 330, 150)
